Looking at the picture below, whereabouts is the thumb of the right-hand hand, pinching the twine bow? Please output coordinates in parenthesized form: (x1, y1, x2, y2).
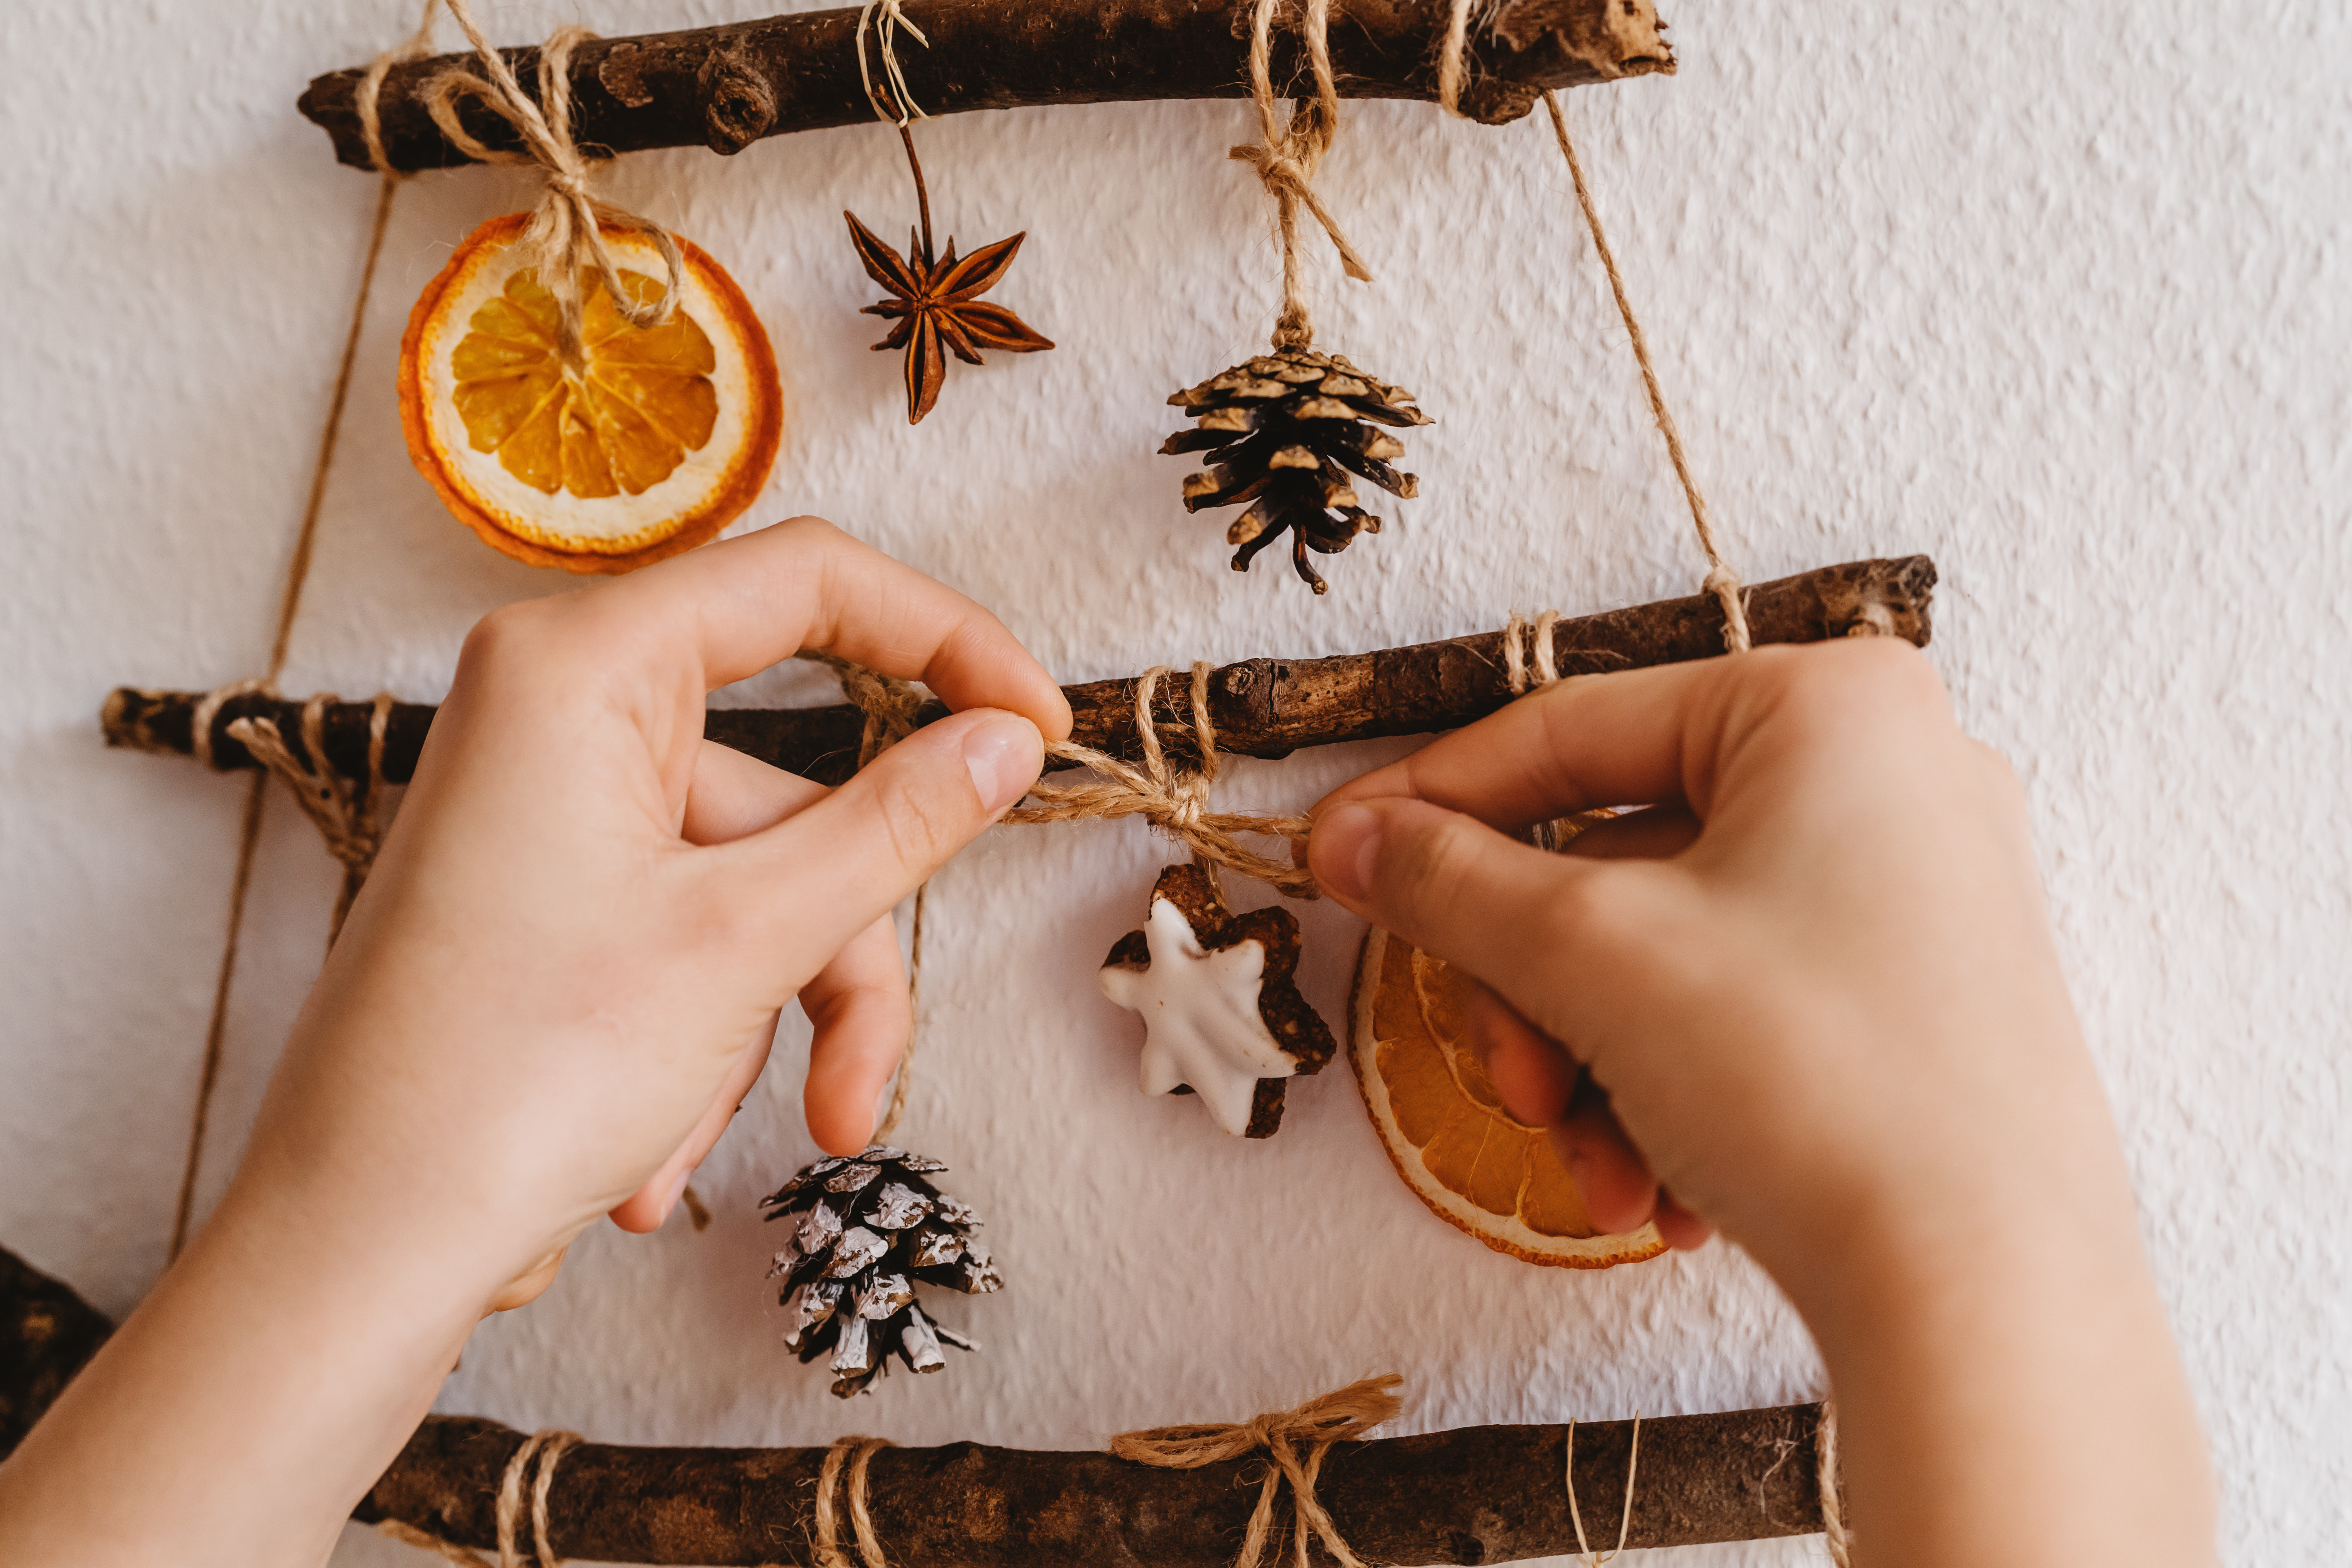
(1308, 797, 1625, 1002)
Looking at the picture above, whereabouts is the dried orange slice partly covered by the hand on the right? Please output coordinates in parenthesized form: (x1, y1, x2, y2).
(1348, 926, 1665, 1269)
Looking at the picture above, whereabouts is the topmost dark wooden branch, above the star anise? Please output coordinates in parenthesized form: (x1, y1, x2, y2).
(301, 0, 1675, 169)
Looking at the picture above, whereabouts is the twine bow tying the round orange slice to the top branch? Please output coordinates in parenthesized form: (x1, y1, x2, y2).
(423, 0, 687, 367)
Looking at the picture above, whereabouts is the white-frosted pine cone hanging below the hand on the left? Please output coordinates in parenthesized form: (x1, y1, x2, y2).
(760, 1143, 1004, 1399)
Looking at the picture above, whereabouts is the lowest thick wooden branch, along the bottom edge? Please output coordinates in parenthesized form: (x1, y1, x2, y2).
(0, 1250, 1820, 1568)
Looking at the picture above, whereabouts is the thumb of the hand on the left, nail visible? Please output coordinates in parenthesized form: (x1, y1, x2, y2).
(706, 708, 1044, 968)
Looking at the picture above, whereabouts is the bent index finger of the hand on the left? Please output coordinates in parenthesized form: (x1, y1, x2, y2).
(597, 517, 1070, 740)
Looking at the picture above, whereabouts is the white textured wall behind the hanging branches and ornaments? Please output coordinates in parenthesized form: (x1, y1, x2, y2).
(0, 0, 2352, 1568)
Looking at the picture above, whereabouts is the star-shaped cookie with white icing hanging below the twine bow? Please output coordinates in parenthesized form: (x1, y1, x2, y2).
(1101, 865, 1338, 1138)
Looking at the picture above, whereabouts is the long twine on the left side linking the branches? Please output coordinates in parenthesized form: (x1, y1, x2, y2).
(165, 0, 440, 1258)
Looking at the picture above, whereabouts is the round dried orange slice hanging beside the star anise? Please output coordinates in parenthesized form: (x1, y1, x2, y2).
(400, 212, 783, 571)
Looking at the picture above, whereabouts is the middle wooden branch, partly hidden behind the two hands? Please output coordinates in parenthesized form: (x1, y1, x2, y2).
(101, 555, 1936, 783)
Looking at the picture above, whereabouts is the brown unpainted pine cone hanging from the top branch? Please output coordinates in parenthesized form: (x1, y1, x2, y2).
(1160, 348, 1432, 592)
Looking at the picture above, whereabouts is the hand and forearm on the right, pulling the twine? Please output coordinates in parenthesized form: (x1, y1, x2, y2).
(1308, 639, 2211, 1566)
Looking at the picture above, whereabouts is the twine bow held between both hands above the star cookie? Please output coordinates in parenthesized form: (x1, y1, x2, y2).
(1004, 663, 1317, 898)
